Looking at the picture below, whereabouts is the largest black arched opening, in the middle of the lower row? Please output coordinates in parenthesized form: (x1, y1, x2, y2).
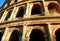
(29, 29, 45, 41)
